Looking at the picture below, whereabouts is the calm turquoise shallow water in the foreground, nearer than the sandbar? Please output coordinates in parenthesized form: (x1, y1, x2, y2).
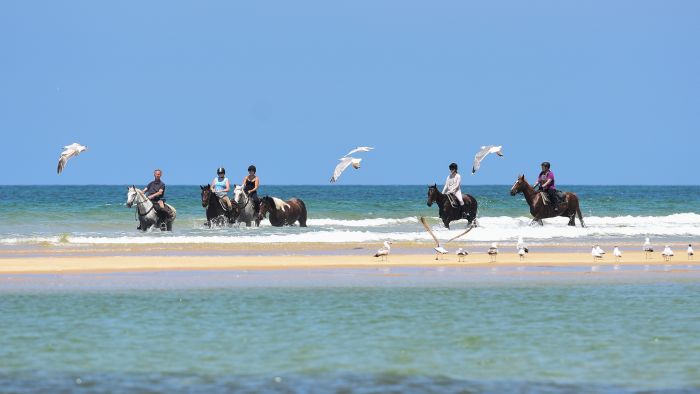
(0, 266, 700, 393)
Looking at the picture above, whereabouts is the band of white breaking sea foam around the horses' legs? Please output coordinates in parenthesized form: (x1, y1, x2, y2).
(0, 213, 700, 245)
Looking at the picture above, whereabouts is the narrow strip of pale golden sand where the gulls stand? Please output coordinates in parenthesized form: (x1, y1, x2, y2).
(0, 244, 695, 274)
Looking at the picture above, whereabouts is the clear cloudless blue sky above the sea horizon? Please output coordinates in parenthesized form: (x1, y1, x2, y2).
(0, 0, 700, 185)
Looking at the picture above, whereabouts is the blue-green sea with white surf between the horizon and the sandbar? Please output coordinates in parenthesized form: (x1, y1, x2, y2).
(0, 185, 700, 245)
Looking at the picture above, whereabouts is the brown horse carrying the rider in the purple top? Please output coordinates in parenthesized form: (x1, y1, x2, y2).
(510, 175, 586, 227)
